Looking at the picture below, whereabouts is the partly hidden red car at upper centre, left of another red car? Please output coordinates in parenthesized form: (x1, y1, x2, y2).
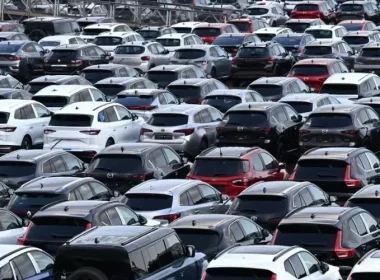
(192, 23, 240, 44)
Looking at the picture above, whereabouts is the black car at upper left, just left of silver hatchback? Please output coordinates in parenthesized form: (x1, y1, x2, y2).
(44, 44, 113, 75)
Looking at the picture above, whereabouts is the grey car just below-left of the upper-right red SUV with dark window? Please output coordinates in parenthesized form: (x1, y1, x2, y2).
(247, 77, 310, 101)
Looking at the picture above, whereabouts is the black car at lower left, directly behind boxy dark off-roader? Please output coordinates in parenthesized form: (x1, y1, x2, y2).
(18, 200, 147, 255)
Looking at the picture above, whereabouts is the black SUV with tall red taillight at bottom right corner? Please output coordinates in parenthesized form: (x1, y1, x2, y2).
(272, 207, 380, 277)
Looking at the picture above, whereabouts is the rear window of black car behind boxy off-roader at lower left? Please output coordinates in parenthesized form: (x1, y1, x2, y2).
(28, 216, 89, 241)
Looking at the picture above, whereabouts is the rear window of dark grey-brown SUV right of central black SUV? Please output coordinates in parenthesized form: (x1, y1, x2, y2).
(306, 114, 352, 128)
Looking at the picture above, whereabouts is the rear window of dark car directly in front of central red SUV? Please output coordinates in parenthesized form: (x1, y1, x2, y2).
(231, 195, 288, 215)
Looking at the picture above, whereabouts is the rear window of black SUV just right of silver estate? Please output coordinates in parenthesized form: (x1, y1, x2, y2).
(223, 111, 268, 127)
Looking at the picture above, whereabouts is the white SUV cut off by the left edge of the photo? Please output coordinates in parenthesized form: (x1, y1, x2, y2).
(0, 99, 51, 154)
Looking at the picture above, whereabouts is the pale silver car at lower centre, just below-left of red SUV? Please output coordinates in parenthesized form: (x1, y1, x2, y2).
(121, 179, 232, 222)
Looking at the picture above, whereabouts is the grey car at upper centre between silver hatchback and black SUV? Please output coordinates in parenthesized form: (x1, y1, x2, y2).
(170, 45, 232, 79)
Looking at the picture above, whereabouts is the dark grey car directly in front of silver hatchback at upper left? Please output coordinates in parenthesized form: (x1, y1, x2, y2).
(80, 63, 140, 84)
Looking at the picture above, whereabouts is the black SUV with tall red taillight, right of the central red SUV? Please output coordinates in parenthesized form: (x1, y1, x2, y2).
(289, 148, 380, 204)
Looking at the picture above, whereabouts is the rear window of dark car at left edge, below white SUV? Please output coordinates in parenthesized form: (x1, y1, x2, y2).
(0, 161, 36, 178)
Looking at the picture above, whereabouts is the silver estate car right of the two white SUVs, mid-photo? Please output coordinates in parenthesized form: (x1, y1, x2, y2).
(140, 104, 223, 158)
